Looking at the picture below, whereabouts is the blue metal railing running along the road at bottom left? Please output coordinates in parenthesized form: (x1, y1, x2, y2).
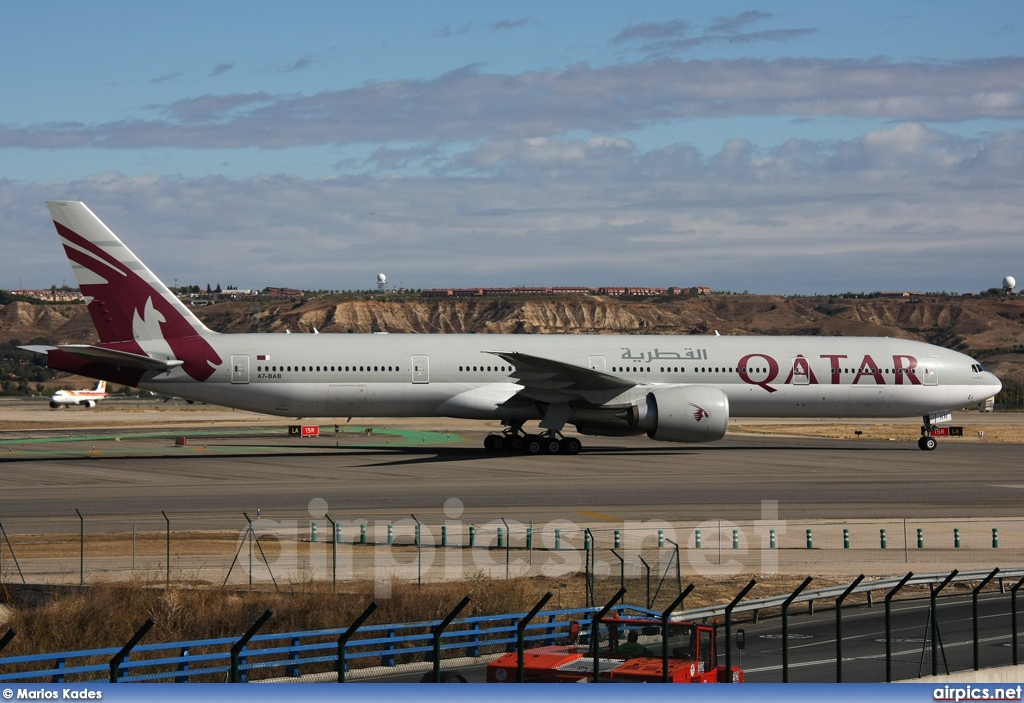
(0, 605, 660, 684)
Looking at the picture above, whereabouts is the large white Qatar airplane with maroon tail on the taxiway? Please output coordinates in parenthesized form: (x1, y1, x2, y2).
(24, 202, 1001, 454)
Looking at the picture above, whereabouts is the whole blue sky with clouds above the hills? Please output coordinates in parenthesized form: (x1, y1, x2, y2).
(0, 0, 1024, 293)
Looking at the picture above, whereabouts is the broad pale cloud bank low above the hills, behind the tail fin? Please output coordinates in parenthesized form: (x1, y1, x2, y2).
(0, 124, 1024, 293)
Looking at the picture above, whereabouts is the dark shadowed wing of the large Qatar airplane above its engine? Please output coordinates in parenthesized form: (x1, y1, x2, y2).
(486, 351, 638, 403)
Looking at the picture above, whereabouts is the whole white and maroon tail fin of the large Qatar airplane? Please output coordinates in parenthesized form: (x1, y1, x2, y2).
(46, 201, 222, 381)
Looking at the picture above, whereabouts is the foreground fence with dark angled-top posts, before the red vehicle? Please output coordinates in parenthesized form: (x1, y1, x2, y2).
(0, 568, 1024, 683)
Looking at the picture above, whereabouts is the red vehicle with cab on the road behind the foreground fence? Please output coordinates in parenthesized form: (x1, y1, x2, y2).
(487, 617, 743, 684)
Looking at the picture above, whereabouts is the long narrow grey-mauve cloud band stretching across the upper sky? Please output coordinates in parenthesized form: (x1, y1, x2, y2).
(0, 58, 1024, 149)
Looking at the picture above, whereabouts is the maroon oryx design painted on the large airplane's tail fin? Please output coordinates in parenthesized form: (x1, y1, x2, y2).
(53, 222, 222, 381)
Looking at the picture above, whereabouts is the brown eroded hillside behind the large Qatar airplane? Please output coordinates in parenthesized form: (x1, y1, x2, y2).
(0, 295, 1024, 381)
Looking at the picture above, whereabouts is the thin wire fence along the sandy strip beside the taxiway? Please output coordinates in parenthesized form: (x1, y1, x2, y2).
(0, 514, 1024, 607)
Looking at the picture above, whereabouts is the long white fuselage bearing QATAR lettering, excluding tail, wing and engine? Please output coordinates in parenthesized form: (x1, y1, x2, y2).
(138, 334, 1000, 422)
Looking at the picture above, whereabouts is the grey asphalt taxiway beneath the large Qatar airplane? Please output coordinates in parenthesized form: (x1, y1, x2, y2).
(0, 417, 1024, 521)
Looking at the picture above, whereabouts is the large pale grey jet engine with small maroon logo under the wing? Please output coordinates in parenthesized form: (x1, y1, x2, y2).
(636, 386, 729, 442)
